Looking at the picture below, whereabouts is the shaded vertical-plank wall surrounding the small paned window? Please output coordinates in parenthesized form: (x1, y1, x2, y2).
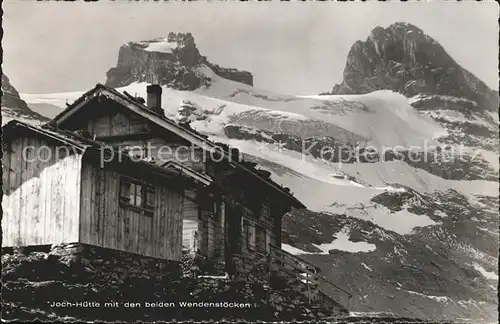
(80, 163, 183, 261)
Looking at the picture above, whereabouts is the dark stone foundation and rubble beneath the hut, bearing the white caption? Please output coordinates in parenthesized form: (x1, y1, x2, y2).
(2, 244, 348, 322)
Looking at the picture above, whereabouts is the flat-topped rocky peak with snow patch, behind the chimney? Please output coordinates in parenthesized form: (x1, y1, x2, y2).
(106, 32, 253, 90)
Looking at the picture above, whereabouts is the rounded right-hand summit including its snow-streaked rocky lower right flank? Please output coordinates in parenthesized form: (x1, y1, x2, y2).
(328, 22, 499, 152)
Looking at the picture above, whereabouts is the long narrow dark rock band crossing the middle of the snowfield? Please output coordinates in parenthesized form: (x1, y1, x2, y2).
(224, 124, 498, 181)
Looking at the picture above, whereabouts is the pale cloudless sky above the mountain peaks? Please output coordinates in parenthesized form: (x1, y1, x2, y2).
(2, 0, 499, 95)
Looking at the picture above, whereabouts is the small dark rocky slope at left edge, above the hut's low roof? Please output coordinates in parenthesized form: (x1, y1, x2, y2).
(2, 73, 48, 125)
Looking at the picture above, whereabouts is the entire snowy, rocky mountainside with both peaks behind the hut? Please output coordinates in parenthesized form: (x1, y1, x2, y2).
(13, 23, 498, 322)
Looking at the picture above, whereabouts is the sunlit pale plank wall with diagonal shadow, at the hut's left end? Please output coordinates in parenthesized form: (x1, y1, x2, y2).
(2, 137, 81, 246)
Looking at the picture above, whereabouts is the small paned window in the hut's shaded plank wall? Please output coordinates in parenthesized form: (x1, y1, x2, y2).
(120, 176, 154, 211)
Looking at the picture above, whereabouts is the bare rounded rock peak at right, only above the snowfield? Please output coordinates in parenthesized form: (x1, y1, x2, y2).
(329, 22, 499, 111)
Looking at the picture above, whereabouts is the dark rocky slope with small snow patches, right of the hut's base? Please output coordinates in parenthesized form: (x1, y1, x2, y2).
(284, 189, 498, 322)
